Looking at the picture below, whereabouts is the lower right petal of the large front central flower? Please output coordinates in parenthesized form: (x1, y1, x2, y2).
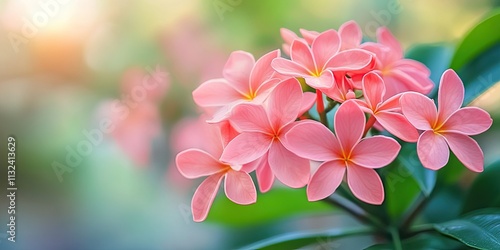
(347, 164, 384, 205)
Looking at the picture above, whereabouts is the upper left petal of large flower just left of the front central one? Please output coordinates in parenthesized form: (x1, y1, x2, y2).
(229, 103, 271, 133)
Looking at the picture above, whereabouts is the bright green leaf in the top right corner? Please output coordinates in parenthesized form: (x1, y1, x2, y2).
(451, 9, 500, 70)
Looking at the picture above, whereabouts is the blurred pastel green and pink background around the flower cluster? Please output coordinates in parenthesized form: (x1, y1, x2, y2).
(0, 0, 500, 249)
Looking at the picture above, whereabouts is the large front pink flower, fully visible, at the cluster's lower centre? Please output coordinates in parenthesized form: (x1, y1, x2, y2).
(286, 101, 401, 204)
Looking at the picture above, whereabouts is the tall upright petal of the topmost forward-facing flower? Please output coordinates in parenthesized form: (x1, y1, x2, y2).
(311, 30, 340, 70)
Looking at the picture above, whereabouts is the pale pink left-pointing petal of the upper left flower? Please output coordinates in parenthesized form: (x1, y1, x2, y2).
(193, 79, 244, 107)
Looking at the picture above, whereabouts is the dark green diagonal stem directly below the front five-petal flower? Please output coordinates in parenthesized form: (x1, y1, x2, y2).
(324, 194, 387, 231)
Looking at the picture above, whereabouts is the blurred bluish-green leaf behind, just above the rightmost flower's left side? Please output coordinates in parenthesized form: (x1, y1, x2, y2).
(405, 43, 453, 94)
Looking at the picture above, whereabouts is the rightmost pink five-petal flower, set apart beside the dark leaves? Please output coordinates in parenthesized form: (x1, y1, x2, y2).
(401, 69, 493, 172)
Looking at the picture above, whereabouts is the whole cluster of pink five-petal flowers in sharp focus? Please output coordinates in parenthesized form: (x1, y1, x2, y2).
(176, 21, 492, 221)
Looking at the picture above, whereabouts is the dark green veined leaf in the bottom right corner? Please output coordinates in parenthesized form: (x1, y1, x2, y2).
(434, 209, 500, 249)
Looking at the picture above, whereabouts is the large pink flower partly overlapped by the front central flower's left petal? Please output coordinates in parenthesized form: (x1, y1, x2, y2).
(221, 78, 314, 192)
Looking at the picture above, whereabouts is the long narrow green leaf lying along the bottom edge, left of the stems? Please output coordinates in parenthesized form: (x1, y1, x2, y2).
(242, 227, 375, 249)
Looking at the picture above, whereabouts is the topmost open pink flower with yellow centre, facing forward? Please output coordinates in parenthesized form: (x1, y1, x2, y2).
(271, 30, 373, 89)
